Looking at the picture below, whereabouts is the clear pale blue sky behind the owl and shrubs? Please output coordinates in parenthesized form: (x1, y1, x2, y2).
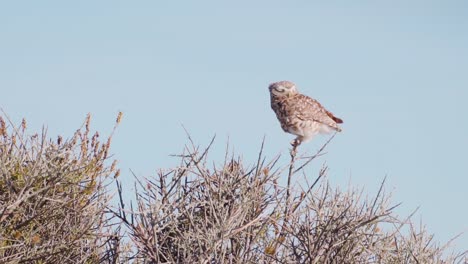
(0, 0, 468, 250)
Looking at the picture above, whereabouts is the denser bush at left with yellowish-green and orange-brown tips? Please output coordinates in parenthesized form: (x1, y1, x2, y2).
(0, 115, 122, 263)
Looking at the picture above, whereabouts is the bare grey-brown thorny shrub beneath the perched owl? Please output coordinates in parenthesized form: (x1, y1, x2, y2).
(115, 136, 466, 263)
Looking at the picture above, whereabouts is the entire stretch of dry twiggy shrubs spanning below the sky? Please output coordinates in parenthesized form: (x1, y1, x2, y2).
(0, 114, 467, 263)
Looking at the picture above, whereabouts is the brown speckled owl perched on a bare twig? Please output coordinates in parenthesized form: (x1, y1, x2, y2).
(268, 81, 343, 146)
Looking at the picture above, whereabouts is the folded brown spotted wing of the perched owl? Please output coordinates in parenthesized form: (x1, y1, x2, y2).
(295, 94, 343, 130)
